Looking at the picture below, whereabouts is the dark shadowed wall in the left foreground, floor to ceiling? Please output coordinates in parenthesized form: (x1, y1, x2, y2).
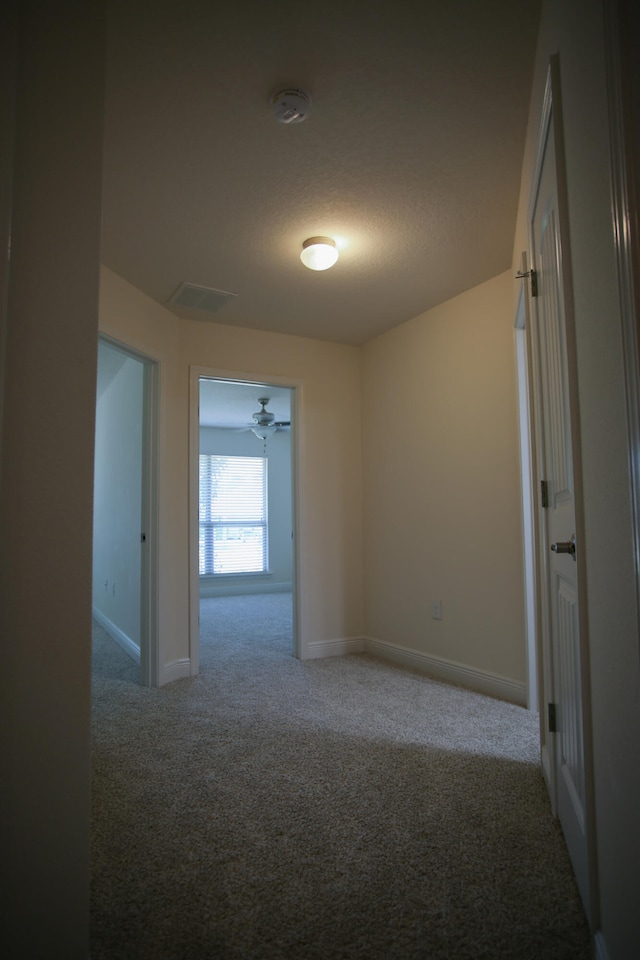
(0, 0, 104, 960)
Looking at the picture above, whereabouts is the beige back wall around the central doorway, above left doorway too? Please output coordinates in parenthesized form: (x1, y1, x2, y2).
(100, 268, 362, 664)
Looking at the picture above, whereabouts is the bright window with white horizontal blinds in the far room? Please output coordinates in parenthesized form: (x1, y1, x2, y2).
(199, 454, 268, 576)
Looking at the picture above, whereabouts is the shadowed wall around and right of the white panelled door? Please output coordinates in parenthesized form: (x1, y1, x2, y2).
(513, 0, 640, 960)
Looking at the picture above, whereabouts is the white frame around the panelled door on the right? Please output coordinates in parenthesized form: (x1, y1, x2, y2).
(525, 55, 599, 929)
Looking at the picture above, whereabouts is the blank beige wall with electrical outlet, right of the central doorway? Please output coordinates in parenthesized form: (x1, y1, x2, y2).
(363, 274, 525, 697)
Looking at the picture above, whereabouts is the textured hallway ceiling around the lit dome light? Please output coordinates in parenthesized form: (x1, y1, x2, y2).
(103, 0, 539, 344)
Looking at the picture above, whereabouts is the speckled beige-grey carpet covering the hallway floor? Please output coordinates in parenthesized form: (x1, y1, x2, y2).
(91, 594, 590, 960)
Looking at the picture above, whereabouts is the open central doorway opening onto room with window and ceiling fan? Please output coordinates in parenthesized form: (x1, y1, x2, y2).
(191, 374, 297, 672)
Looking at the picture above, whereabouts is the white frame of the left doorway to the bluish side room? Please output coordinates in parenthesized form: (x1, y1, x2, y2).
(98, 332, 160, 687)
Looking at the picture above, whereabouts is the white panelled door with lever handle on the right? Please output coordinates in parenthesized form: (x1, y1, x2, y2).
(529, 65, 589, 913)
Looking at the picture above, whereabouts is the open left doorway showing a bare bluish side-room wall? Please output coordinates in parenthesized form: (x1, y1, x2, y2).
(92, 337, 158, 686)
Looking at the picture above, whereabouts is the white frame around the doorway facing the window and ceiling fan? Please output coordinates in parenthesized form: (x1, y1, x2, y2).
(189, 366, 304, 676)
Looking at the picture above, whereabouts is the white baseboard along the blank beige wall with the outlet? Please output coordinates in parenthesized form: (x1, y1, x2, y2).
(364, 637, 527, 707)
